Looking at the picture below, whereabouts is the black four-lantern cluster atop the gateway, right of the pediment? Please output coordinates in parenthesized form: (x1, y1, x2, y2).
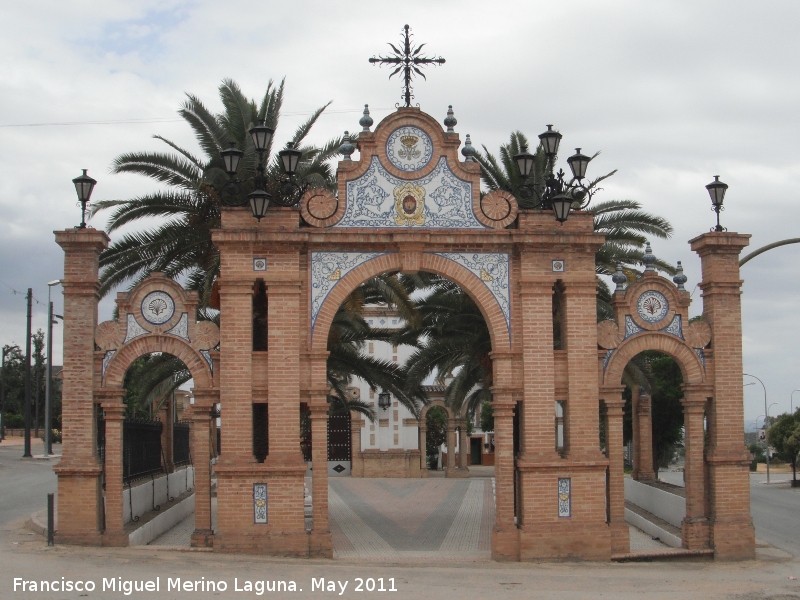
(514, 125, 594, 224)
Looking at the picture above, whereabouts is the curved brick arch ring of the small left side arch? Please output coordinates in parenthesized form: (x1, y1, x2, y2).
(103, 335, 214, 388)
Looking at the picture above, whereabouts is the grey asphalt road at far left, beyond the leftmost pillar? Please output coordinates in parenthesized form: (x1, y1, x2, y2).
(0, 440, 61, 527)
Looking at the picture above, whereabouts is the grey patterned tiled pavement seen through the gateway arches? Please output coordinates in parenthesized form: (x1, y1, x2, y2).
(150, 477, 667, 562)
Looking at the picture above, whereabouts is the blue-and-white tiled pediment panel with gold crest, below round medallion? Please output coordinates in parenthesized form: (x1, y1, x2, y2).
(338, 156, 482, 229)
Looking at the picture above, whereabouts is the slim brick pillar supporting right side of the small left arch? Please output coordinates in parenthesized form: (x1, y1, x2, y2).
(191, 389, 217, 548)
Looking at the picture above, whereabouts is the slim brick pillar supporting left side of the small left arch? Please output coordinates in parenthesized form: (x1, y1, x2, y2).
(102, 400, 128, 546)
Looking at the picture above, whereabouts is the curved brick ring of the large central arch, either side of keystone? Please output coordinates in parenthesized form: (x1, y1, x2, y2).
(311, 252, 511, 350)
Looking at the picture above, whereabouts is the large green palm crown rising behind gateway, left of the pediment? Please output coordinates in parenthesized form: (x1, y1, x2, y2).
(94, 80, 341, 306)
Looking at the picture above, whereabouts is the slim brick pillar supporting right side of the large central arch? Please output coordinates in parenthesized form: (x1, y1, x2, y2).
(492, 388, 519, 561)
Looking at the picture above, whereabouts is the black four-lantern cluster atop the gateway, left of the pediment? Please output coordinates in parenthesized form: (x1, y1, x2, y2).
(216, 124, 307, 221)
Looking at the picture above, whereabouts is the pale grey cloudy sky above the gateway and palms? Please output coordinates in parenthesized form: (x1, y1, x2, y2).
(0, 0, 800, 426)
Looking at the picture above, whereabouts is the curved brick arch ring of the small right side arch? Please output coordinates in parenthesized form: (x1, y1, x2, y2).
(603, 333, 705, 385)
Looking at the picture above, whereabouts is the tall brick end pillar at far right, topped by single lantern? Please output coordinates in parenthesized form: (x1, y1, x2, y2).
(690, 232, 755, 559)
